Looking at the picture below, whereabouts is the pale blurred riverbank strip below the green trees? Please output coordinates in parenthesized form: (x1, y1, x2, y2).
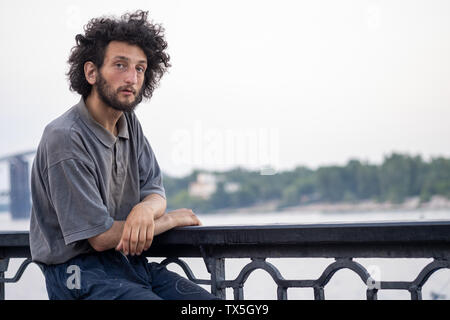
(210, 196, 450, 213)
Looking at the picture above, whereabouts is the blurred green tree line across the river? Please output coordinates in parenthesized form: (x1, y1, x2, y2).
(164, 153, 450, 212)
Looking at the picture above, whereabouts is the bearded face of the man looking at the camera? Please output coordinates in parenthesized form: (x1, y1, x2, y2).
(94, 41, 147, 112)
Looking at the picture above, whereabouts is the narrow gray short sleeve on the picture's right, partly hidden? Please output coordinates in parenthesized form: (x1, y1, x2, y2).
(138, 137, 166, 201)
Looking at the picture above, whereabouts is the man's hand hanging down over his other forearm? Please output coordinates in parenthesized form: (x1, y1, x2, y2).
(116, 203, 155, 256)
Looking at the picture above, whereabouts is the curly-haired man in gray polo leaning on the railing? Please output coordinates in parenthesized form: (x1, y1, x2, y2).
(30, 11, 219, 299)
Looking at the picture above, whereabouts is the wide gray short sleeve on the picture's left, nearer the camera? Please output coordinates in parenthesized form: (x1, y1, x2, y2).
(47, 159, 114, 245)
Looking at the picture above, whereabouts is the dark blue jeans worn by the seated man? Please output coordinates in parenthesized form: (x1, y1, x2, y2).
(39, 249, 218, 300)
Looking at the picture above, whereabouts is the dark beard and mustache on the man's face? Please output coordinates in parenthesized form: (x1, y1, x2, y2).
(96, 72, 144, 112)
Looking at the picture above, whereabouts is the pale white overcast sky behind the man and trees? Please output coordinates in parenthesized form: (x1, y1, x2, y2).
(0, 0, 450, 175)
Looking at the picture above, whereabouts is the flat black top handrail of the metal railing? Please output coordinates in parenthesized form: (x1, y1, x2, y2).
(0, 221, 450, 258)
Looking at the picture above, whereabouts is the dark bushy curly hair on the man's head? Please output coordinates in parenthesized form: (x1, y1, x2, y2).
(66, 10, 171, 99)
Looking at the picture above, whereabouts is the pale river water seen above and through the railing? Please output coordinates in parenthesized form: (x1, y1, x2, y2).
(0, 210, 450, 300)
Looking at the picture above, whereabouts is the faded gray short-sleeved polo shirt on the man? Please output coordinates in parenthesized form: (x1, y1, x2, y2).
(30, 98, 165, 264)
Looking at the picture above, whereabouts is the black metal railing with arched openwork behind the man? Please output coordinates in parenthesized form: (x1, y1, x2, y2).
(0, 221, 450, 300)
